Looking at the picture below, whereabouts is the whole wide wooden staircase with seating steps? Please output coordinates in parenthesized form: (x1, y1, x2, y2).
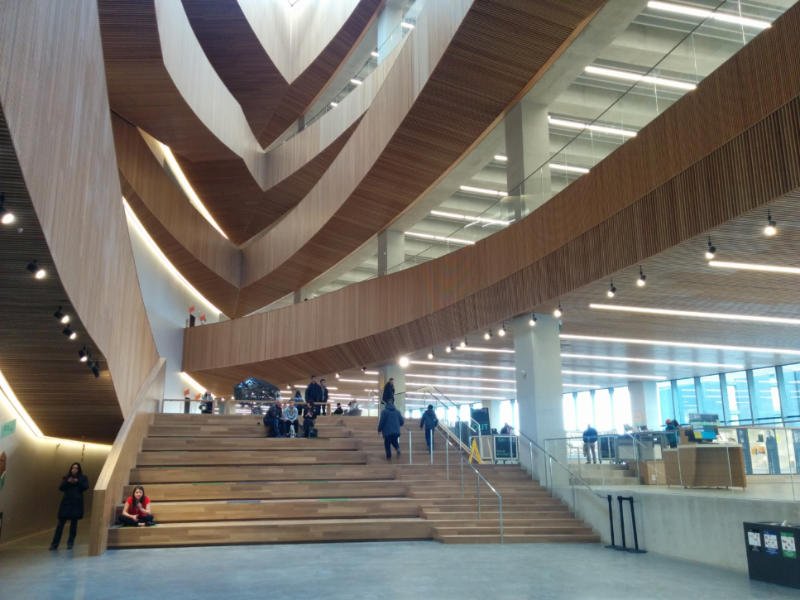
(108, 414, 599, 548)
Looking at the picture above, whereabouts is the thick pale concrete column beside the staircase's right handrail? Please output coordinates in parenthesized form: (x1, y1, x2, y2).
(512, 315, 564, 479)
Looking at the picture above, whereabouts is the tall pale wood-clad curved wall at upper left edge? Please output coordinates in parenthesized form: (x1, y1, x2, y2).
(0, 0, 158, 422)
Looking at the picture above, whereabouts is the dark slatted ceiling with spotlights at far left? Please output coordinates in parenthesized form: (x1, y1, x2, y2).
(0, 106, 122, 443)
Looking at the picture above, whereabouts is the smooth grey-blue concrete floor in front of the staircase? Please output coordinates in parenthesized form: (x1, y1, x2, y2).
(0, 533, 800, 600)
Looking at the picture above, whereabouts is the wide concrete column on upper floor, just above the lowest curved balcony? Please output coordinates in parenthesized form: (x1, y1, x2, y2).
(504, 101, 550, 219)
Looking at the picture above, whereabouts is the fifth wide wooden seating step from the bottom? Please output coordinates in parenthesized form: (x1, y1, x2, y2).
(136, 450, 367, 467)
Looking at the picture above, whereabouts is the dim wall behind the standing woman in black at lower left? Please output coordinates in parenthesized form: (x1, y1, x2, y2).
(0, 391, 110, 544)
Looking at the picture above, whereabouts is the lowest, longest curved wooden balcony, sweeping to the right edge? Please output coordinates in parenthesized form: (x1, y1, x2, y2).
(184, 5, 800, 392)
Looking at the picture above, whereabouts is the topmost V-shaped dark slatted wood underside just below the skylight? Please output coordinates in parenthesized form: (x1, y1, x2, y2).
(183, 0, 385, 148)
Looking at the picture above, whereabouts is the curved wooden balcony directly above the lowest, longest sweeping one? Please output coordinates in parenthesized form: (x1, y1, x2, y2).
(234, 0, 602, 314)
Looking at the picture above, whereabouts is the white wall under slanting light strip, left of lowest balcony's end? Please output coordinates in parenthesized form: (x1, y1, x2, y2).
(128, 213, 220, 399)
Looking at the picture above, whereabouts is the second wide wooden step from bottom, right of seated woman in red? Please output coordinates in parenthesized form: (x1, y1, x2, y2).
(133, 498, 420, 523)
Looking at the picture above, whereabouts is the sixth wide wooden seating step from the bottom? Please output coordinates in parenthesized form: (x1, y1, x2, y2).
(142, 436, 361, 452)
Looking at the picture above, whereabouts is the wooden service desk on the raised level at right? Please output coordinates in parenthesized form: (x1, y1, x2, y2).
(664, 444, 747, 488)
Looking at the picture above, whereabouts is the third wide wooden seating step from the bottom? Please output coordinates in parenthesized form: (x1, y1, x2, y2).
(123, 480, 408, 502)
